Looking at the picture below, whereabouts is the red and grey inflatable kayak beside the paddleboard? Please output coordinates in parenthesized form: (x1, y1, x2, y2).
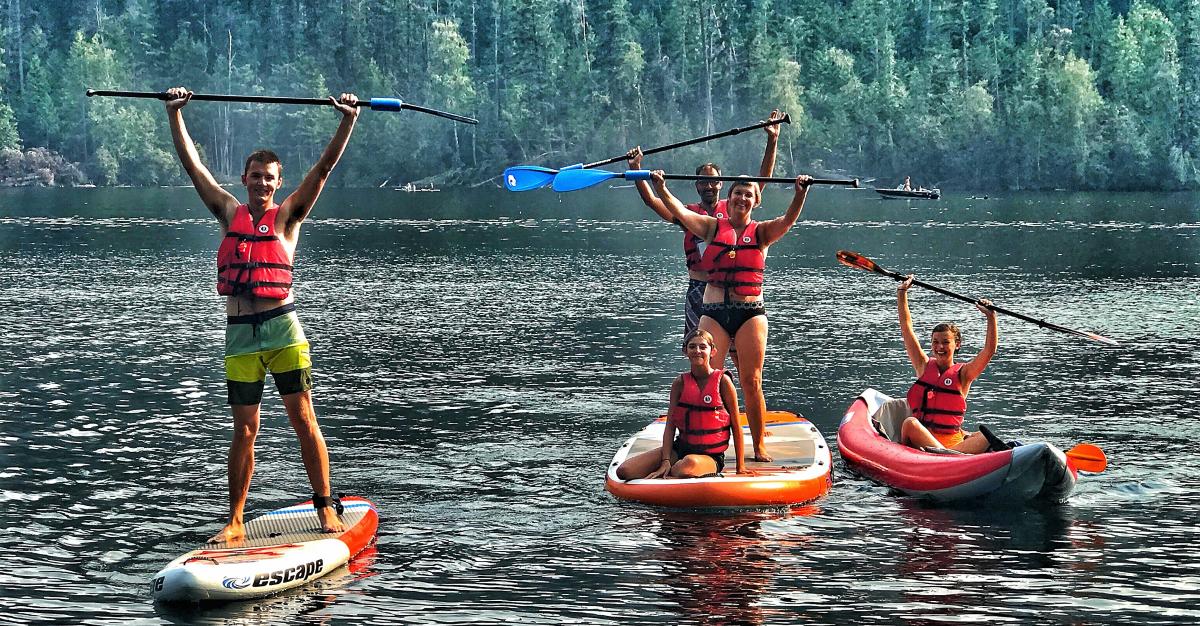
(838, 389, 1079, 502)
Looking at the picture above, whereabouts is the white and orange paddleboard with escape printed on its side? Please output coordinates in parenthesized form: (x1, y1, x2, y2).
(150, 496, 379, 602)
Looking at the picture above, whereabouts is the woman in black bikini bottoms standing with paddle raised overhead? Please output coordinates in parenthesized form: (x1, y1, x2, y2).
(650, 170, 812, 462)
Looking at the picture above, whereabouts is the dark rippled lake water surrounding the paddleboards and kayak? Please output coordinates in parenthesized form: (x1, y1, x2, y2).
(0, 185, 1200, 625)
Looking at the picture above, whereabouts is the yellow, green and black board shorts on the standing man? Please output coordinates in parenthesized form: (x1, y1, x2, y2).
(226, 303, 312, 404)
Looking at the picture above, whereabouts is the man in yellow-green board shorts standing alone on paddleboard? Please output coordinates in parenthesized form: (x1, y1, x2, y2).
(167, 88, 359, 543)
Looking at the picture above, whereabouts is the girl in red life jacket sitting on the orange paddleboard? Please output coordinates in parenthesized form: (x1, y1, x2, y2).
(617, 330, 746, 481)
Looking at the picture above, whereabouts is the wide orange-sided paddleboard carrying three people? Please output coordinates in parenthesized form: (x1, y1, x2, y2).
(605, 411, 833, 508)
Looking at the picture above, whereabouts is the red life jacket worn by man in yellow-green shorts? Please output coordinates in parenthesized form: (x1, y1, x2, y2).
(217, 204, 292, 300)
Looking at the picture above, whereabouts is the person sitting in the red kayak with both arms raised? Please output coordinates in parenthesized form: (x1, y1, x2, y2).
(896, 275, 1007, 455)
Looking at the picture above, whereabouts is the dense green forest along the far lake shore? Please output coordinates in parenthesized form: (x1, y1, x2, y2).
(0, 0, 1200, 189)
